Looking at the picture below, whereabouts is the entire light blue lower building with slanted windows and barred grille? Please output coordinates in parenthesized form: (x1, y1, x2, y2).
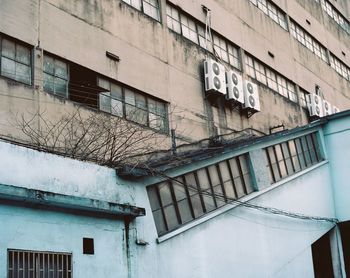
(0, 111, 350, 278)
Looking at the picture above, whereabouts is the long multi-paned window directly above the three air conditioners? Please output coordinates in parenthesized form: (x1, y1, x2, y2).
(166, 4, 241, 69)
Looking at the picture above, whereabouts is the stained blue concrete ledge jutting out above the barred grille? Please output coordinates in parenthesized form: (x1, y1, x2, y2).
(0, 184, 146, 218)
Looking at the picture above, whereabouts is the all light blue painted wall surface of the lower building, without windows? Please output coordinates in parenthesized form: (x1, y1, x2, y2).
(0, 121, 342, 278)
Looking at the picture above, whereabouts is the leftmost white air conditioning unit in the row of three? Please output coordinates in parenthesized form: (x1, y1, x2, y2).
(204, 59, 226, 95)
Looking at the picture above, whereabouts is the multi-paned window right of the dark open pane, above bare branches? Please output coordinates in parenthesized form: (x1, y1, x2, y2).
(98, 78, 168, 132)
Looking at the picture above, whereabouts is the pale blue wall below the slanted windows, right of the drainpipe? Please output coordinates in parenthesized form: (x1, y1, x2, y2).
(135, 163, 335, 278)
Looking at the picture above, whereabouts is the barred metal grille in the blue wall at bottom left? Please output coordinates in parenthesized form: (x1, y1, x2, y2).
(7, 250, 72, 278)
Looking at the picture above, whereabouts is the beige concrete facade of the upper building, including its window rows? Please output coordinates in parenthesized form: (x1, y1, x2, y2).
(0, 0, 350, 146)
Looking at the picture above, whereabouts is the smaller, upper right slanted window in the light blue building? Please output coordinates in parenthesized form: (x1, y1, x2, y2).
(265, 133, 323, 183)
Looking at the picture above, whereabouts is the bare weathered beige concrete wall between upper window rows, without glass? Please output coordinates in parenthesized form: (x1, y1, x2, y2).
(0, 0, 350, 141)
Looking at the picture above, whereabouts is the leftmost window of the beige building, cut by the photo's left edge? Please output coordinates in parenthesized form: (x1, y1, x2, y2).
(0, 36, 32, 85)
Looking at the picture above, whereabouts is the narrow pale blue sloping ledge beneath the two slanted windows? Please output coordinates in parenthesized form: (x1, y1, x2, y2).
(157, 160, 328, 243)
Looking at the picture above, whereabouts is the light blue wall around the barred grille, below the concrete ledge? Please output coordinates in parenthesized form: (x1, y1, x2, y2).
(0, 205, 127, 278)
